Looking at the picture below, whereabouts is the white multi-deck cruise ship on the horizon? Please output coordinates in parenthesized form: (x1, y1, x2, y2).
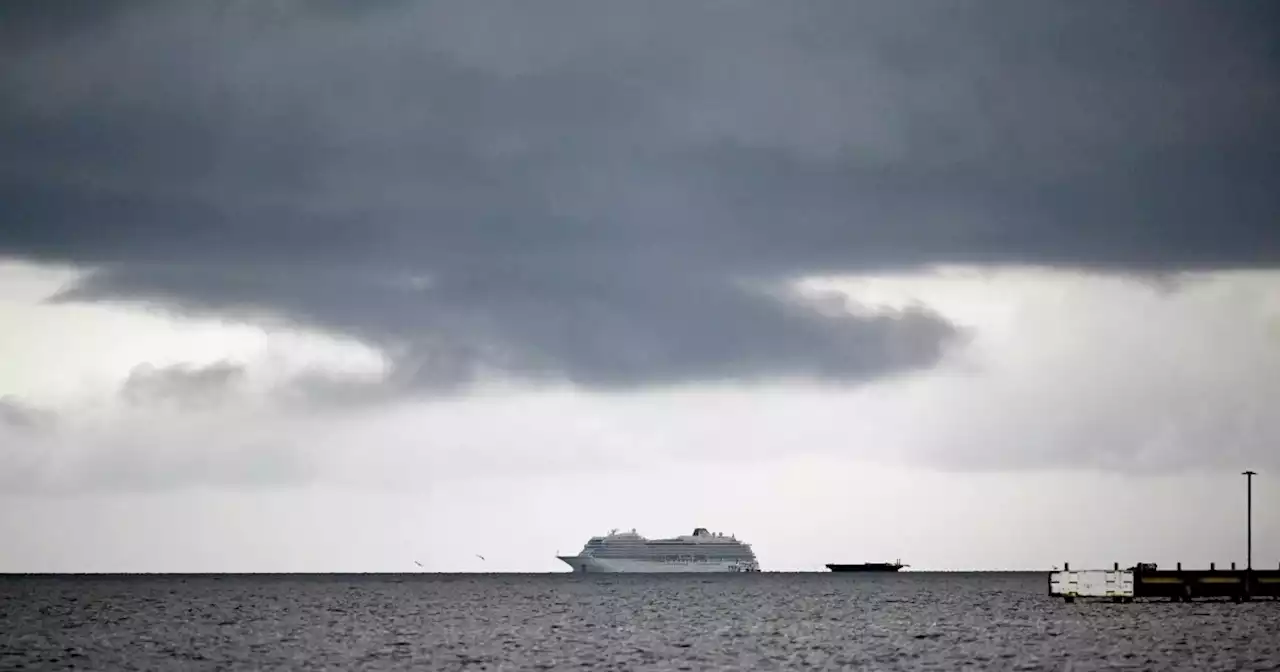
(557, 527, 760, 572)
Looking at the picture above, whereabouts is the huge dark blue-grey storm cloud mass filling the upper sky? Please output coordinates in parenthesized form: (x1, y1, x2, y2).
(0, 0, 1280, 388)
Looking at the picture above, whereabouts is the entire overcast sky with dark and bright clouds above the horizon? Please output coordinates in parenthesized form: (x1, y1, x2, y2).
(0, 0, 1280, 571)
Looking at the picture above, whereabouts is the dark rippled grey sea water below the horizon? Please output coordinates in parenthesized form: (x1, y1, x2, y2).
(0, 573, 1280, 671)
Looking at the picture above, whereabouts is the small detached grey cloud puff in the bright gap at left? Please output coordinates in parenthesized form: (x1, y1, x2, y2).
(120, 362, 244, 408)
